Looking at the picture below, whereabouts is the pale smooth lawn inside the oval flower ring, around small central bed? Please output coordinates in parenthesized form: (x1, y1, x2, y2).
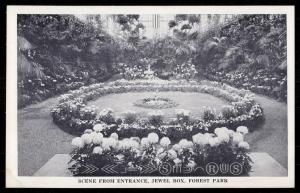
(88, 92, 226, 119)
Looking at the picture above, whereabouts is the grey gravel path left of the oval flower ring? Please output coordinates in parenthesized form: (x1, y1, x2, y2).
(18, 97, 73, 176)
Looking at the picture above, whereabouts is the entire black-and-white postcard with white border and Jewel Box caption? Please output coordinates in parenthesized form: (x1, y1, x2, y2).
(6, 6, 295, 188)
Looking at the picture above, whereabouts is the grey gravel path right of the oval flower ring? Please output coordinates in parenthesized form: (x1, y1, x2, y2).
(246, 95, 288, 168)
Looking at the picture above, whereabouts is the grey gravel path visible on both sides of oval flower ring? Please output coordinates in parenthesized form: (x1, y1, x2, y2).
(18, 92, 287, 176)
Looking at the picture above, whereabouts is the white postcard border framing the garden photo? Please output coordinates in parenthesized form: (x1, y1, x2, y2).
(6, 6, 295, 188)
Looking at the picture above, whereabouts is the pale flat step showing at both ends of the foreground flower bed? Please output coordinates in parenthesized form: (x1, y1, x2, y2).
(34, 152, 287, 177)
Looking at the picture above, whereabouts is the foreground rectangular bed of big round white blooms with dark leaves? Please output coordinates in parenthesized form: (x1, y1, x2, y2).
(69, 124, 252, 176)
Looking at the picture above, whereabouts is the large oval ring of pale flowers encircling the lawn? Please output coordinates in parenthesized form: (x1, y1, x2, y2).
(51, 80, 263, 136)
